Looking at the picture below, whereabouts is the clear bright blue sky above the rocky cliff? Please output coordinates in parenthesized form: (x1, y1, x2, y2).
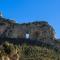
(0, 0, 60, 38)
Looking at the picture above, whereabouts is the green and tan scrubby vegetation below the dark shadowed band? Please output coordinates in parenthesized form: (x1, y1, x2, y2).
(0, 42, 60, 60)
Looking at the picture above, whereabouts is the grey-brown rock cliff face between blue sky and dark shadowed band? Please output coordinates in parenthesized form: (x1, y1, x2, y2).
(0, 17, 55, 40)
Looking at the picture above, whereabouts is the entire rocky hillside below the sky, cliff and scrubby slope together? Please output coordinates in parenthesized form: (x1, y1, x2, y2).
(0, 17, 60, 60)
